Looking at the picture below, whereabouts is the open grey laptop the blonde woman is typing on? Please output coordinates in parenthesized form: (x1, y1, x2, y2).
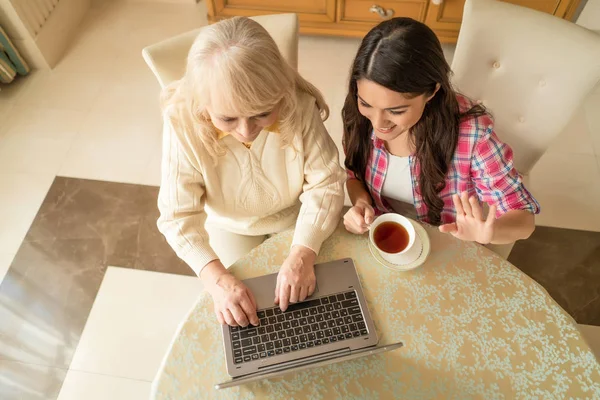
(215, 258, 402, 389)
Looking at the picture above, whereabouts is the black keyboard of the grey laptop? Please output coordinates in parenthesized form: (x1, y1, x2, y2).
(229, 290, 369, 364)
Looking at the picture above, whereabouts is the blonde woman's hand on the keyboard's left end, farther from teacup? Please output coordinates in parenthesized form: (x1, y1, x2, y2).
(202, 263, 259, 326)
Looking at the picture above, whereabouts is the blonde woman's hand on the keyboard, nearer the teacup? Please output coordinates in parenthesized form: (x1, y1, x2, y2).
(275, 245, 317, 311)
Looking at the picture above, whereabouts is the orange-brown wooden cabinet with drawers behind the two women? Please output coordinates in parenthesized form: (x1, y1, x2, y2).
(206, 0, 580, 43)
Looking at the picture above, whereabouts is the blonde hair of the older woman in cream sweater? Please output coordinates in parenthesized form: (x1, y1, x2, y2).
(161, 17, 329, 162)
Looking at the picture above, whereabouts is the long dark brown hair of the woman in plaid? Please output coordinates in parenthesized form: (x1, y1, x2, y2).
(342, 18, 485, 225)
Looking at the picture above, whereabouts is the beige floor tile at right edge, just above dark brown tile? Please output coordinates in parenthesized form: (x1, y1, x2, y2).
(529, 153, 600, 231)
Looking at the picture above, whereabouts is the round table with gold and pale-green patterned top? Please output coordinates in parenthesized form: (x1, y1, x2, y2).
(152, 222, 600, 400)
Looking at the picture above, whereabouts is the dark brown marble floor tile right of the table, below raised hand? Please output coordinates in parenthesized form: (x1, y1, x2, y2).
(508, 226, 600, 325)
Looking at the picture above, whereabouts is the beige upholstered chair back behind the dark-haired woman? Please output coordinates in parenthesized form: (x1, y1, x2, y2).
(452, 0, 600, 174)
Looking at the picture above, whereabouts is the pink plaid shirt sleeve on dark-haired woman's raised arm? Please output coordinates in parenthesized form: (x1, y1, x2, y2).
(471, 120, 540, 218)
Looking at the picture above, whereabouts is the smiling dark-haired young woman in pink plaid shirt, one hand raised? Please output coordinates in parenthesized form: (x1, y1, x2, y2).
(342, 18, 540, 244)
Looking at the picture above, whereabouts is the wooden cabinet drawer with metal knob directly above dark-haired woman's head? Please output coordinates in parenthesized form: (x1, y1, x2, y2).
(338, 0, 427, 25)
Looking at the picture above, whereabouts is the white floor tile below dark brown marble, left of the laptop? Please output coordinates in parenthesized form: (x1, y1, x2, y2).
(70, 267, 202, 381)
